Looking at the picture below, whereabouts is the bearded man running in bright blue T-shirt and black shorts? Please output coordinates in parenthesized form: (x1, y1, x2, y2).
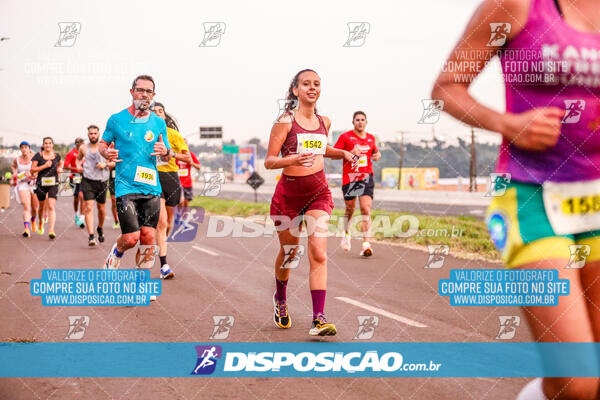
(100, 75, 173, 269)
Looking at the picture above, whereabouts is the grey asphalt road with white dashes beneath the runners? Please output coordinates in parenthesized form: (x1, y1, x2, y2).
(0, 198, 531, 400)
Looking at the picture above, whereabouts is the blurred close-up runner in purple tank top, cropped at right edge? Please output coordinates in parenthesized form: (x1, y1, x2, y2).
(432, 0, 600, 400)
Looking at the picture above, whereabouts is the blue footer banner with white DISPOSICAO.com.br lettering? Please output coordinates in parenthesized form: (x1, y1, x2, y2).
(0, 342, 600, 377)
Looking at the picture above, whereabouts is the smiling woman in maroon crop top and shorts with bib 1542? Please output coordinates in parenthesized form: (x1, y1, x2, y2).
(265, 69, 358, 336)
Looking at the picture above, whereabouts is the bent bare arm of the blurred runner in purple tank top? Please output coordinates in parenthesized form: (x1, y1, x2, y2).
(431, 0, 564, 150)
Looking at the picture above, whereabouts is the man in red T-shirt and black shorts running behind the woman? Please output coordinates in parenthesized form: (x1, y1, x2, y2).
(334, 111, 381, 257)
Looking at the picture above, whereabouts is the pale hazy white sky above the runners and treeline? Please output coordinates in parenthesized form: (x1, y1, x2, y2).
(0, 0, 504, 144)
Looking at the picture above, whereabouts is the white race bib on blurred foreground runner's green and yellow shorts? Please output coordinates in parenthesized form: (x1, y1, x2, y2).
(543, 179, 600, 235)
